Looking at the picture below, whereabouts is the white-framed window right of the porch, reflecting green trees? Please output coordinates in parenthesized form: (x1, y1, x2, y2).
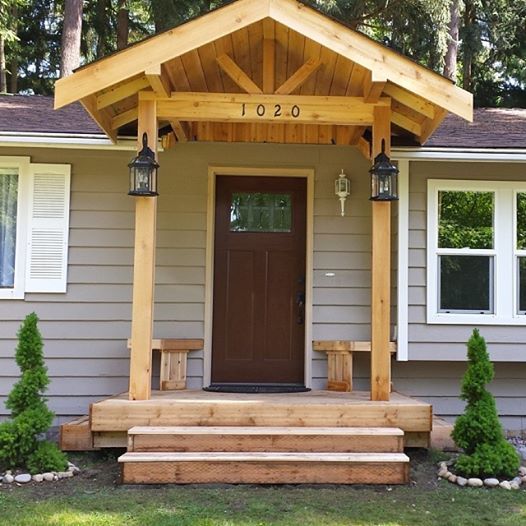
(427, 179, 526, 325)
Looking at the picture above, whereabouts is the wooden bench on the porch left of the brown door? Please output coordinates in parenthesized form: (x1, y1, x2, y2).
(128, 338, 204, 391)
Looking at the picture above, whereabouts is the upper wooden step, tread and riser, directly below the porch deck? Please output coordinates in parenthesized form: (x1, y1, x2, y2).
(128, 426, 404, 453)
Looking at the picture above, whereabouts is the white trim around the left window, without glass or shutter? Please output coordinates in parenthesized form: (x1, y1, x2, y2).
(0, 157, 31, 299)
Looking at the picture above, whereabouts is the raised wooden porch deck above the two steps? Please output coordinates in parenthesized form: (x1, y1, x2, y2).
(90, 390, 432, 447)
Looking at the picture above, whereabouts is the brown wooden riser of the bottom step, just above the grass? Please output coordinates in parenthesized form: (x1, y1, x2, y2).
(122, 461, 409, 484)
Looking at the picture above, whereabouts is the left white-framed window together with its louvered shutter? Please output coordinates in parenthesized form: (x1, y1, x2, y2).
(0, 157, 70, 299)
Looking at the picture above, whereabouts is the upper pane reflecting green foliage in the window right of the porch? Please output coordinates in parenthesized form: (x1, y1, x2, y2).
(438, 191, 494, 249)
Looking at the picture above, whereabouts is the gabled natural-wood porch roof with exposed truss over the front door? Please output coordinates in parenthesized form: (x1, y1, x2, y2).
(55, 0, 473, 155)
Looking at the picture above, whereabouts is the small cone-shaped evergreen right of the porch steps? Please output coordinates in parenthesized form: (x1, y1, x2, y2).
(452, 329, 520, 477)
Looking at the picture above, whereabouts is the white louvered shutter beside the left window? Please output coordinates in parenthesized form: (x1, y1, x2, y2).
(26, 164, 71, 292)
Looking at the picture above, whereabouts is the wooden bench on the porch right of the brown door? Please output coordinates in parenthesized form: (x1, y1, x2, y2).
(312, 340, 396, 392)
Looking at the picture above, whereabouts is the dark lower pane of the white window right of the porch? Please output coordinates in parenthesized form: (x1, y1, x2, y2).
(438, 256, 493, 313)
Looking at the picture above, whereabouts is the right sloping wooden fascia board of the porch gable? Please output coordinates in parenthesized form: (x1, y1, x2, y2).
(269, 0, 473, 122)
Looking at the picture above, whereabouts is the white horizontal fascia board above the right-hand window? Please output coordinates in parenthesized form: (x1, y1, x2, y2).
(392, 148, 526, 163)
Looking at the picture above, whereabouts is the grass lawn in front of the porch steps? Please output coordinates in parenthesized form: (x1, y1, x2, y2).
(0, 453, 526, 526)
